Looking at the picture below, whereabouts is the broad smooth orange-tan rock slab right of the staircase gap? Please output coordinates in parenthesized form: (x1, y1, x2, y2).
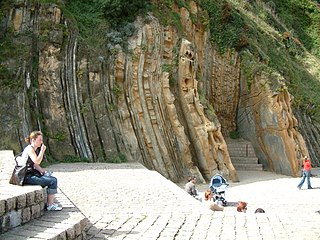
(238, 75, 308, 176)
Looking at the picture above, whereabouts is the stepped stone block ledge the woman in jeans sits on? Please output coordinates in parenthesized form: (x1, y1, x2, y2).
(0, 151, 87, 240)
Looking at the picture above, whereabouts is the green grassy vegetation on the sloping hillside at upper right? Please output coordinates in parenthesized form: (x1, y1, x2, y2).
(197, 0, 320, 121)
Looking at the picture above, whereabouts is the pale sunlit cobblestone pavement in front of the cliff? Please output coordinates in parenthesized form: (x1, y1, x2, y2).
(50, 163, 320, 240)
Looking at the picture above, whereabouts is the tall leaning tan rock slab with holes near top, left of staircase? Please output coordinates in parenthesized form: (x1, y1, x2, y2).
(178, 40, 237, 180)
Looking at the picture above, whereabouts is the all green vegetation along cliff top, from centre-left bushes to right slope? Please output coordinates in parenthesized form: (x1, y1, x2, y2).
(38, 0, 320, 121)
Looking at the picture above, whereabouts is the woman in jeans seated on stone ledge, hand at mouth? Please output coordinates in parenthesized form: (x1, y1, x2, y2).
(22, 131, 62, 211)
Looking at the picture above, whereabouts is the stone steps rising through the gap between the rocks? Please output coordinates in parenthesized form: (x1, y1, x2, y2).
(226, 139, 263, 171)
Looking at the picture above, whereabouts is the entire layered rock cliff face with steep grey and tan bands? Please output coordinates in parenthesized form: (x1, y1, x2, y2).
(0, 1, 307, 181)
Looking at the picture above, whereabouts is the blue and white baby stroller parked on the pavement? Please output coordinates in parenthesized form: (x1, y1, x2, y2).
(209, 174, 229, 206)
